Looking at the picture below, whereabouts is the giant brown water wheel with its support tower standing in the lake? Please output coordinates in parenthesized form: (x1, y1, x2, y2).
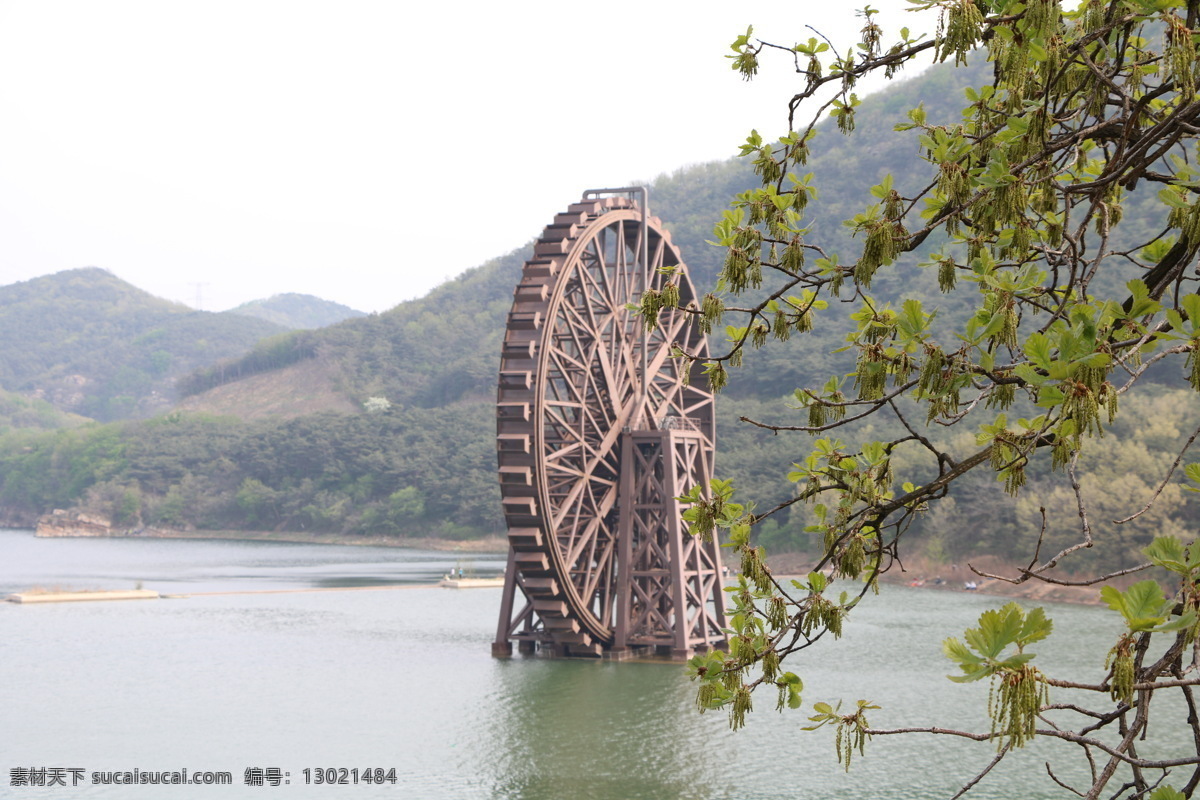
(493, 187, 725, 657)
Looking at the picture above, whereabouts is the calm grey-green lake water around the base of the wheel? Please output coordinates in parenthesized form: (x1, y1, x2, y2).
(0, 530, 1186, 800)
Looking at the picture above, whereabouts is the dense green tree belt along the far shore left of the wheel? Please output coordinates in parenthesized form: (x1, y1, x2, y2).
(0, 404, 496, 537)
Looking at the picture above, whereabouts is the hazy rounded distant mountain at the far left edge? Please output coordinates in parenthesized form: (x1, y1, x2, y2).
(0, 267, 283, 420)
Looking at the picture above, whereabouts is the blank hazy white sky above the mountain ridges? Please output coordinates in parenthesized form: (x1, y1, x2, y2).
(0, 0, 936, 311)
